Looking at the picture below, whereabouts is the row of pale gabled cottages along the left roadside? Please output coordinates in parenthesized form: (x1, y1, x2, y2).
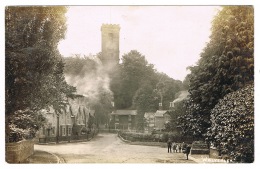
(38, 97, 96, 142)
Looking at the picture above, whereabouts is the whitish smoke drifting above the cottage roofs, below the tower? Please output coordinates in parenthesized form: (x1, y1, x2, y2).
(65, 57, 112, 102)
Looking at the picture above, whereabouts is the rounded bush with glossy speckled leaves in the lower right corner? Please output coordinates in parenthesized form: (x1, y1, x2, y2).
(207, 84, 254, 163)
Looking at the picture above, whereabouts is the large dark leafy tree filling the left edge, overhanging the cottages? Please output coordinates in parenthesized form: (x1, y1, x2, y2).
(5, 6, 75, 140)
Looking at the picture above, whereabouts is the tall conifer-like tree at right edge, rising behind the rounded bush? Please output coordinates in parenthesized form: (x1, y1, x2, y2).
(182, 6, 254, 138)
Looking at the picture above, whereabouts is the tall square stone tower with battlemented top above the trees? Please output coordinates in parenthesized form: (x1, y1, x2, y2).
(101, 24, 120, 67)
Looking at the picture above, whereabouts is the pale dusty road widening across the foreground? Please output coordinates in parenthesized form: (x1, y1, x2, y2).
(34, 133, 195, 163)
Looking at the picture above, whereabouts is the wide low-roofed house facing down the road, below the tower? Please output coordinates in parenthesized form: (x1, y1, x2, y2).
(109, 110, 137, 130)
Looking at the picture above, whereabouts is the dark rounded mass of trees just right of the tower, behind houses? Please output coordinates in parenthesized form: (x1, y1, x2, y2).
(111, 50, 184, 130)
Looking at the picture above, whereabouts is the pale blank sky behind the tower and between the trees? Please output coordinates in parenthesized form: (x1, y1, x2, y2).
(58, 6, 220, 81)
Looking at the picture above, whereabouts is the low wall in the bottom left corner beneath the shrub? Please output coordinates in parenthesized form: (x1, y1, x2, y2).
(5, 140, 34, 163)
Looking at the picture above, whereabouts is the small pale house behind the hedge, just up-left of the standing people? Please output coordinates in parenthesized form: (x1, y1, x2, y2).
(154, 110, 171, 130)
